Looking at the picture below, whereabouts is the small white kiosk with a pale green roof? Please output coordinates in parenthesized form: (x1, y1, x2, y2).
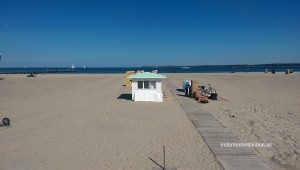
(128, 72, 166, 102)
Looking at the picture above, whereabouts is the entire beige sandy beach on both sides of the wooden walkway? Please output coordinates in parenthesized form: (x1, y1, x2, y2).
(0, 73, 300, 170)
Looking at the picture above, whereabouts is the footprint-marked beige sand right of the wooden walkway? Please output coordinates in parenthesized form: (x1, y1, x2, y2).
(168, 73, 300, 169)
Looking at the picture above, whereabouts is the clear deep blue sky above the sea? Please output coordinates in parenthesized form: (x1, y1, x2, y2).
(0, 0, 300, 67)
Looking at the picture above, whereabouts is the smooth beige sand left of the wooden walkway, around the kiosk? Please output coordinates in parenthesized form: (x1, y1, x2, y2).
(0, 74, 219, 170)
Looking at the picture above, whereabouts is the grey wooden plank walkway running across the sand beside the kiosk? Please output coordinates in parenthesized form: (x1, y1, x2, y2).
(166, 81, 271, 170)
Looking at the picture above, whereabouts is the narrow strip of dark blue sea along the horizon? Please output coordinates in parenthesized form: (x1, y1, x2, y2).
(0, 64, 300, 74)
